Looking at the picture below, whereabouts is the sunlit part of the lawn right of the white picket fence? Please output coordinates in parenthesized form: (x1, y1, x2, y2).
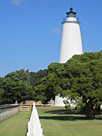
(37, 107, 102, 136)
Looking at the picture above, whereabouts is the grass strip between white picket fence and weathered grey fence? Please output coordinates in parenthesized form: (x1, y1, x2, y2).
(0, 111, 31, 136)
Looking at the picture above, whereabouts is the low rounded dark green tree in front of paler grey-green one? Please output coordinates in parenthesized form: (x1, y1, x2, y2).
(1, 82, 34, 104)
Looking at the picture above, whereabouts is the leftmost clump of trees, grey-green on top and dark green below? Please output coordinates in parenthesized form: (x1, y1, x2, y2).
(0, 69, 34, 104)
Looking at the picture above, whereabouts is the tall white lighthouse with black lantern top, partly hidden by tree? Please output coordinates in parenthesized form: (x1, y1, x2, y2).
(55, 8, 82, 106)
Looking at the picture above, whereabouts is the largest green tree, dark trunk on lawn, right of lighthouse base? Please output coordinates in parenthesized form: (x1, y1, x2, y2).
(57, 52, 102, 119)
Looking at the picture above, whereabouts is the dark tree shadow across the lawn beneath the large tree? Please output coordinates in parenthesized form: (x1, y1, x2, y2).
(39, 109, 102, 121)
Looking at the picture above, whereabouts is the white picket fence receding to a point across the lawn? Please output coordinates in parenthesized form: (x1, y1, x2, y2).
(27, 103, 44, 136)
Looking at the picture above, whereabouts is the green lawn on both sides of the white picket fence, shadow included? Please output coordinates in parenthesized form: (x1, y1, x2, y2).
(0, 107, 102, 136)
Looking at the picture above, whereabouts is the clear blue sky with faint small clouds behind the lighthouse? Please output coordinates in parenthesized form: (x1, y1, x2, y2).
(0, 0, 102, 77)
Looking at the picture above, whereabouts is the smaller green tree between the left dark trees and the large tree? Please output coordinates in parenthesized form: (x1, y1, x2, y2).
(35, 63, 62, 103)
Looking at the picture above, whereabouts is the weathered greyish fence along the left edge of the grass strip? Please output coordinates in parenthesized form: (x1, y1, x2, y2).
(0, 104, 20, 122)
